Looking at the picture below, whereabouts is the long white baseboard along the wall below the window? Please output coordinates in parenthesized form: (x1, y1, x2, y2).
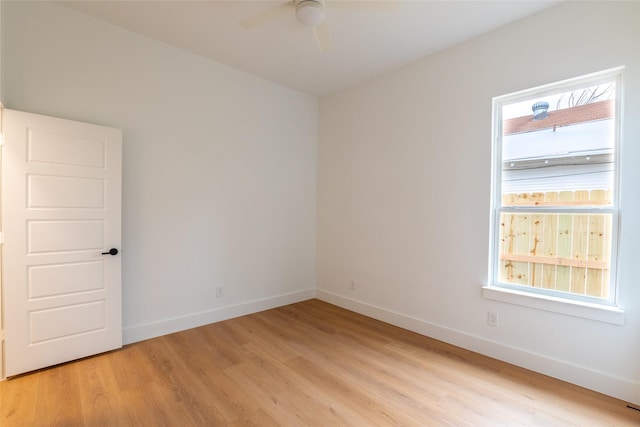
(316, 289, 640, 405)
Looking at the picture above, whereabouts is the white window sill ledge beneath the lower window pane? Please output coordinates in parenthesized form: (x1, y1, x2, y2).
(482, 286, 624, 325)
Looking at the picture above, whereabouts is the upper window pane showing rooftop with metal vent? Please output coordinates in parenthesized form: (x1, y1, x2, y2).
(501, 82, 615, 206)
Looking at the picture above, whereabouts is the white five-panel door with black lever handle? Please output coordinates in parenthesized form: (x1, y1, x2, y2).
(2, 110, 122, 376)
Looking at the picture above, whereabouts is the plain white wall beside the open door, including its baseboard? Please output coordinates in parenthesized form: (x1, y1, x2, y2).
(3, 2, 318, 342)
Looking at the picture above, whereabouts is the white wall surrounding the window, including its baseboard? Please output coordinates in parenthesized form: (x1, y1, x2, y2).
(317, 2, 640, 403)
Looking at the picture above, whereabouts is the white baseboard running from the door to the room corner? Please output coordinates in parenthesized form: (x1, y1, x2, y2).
(122, 289, 315, 344)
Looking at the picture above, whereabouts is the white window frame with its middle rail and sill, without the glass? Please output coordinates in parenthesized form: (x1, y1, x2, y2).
(483, 67, 624, 324)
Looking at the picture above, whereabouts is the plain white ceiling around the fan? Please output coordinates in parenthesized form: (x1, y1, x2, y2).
(58, 0, 559, 97)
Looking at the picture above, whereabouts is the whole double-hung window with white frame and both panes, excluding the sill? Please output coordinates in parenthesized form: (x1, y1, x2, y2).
(489, 69, 622, 305)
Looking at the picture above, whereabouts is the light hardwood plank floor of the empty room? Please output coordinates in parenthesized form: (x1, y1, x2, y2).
(0, 300, 640, 427)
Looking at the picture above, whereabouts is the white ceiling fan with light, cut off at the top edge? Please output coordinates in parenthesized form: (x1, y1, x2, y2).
(239, 0, 397, 52)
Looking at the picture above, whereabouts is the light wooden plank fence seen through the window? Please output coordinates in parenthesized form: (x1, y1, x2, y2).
(499, 190, 612, 298)
